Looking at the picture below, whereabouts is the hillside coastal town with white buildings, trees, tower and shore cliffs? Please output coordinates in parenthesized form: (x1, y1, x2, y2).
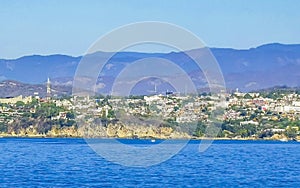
(0, 78, 300, 141)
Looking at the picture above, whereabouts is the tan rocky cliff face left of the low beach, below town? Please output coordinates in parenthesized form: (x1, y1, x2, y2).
(0, 124, 191, 139)
